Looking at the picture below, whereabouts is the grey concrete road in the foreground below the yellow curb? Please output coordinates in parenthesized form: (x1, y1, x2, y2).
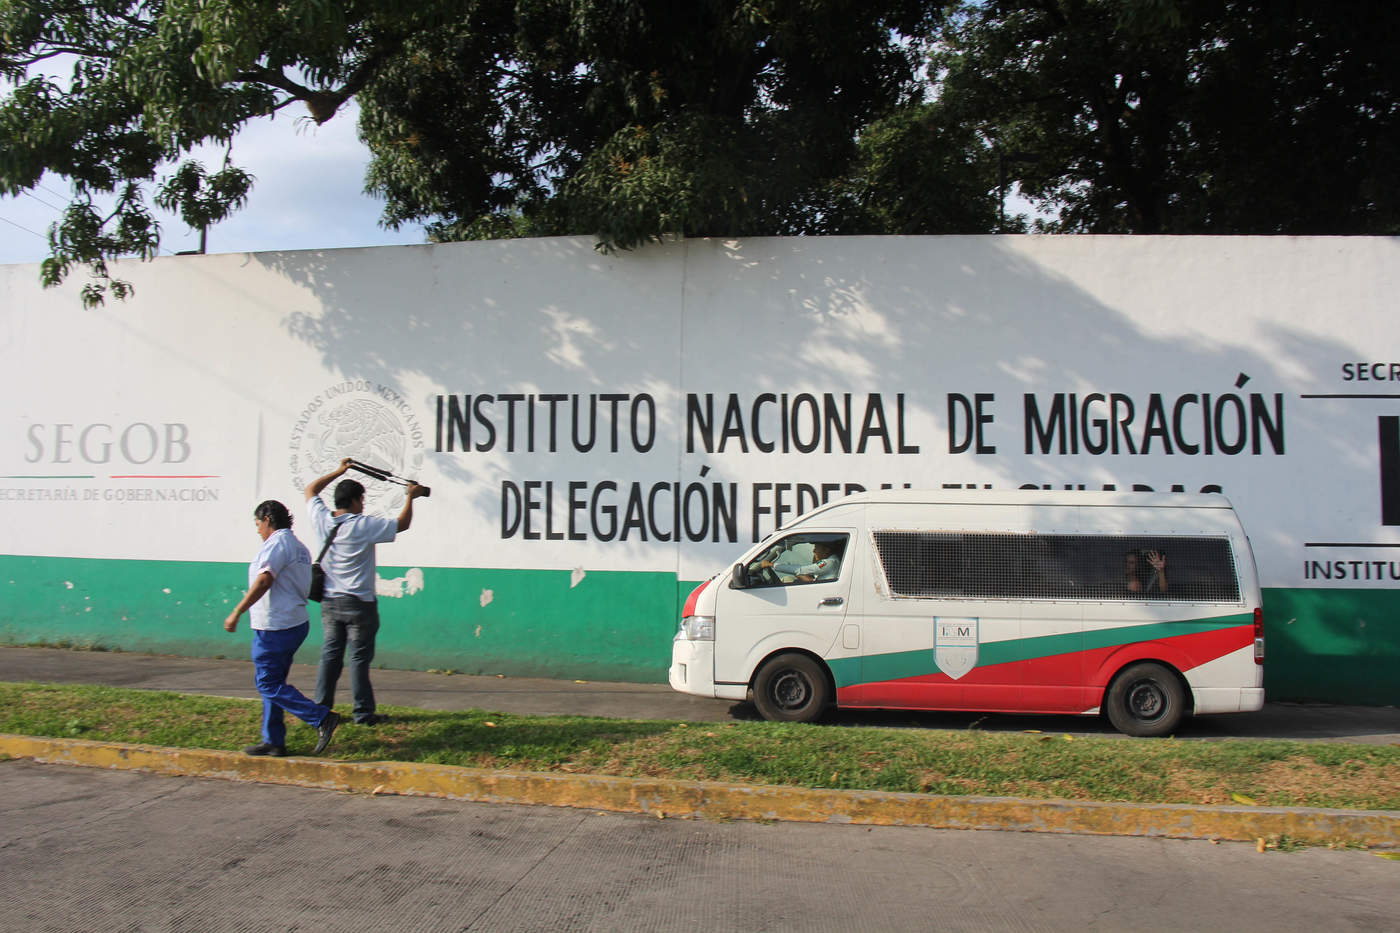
(8, 761, 1400, 933)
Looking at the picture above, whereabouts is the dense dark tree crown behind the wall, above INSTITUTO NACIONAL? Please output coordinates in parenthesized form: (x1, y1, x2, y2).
(352, 0, 937, 248)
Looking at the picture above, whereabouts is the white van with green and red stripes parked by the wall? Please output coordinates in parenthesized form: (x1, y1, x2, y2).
(671, 490, 1264, 735)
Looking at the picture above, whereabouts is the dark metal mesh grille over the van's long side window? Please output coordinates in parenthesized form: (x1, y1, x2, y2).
(874, 531, 1239, 602)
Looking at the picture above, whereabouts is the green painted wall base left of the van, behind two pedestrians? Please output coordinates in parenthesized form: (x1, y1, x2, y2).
(0, 556, 689, 684)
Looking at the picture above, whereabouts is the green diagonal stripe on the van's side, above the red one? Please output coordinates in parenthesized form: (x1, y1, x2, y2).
(829, 612, 1254, 688)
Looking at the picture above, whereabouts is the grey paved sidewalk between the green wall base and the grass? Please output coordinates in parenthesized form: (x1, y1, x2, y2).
(0, 647, 1400, 744)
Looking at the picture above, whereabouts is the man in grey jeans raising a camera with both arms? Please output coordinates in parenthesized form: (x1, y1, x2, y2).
(307, 457, 427, 726)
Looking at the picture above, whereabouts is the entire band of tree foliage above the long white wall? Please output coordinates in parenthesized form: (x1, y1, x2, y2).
(0, 0, 1400, 301)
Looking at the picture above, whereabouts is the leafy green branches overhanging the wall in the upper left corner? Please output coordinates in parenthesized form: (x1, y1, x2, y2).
(0, 0, 470, 304)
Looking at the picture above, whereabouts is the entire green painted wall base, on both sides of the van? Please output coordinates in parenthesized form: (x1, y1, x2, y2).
(0, 556, 1400, 706)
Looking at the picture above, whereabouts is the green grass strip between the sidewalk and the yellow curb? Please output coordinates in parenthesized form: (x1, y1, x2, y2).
(0, 684, 1400, 810)
